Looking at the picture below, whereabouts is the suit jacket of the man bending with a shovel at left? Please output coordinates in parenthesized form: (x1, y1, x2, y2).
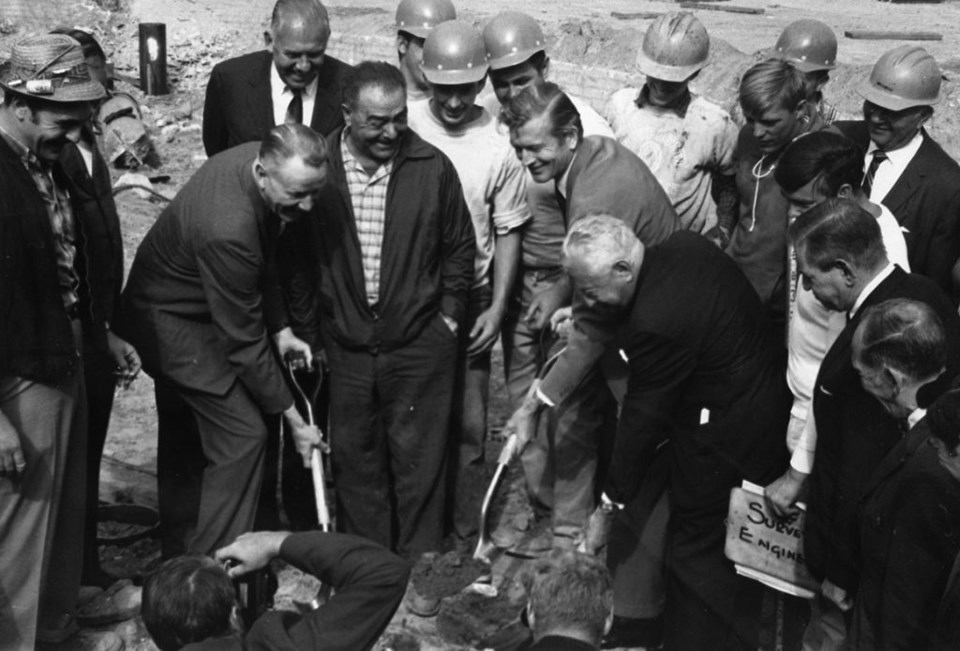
(119, 143, 293, 413)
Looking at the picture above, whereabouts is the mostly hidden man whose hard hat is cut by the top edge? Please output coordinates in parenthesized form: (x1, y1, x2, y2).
(396, 0, 457, 102)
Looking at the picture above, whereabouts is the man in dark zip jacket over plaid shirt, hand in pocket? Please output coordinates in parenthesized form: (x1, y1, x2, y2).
(288, 61, 477, 557)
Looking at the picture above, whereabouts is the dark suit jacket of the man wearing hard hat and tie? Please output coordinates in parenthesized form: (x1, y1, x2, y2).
(835, 120, 960, 303)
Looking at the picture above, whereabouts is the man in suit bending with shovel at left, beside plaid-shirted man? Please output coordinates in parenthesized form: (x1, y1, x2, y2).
(115, 124, 327, 557)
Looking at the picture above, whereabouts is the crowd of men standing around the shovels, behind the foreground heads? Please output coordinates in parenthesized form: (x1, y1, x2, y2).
(0, 0, 960, 651)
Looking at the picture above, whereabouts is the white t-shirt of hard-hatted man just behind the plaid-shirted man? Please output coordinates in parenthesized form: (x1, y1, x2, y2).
(407, 102, 530, 287)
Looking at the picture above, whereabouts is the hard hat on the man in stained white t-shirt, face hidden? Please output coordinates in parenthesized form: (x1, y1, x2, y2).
(637, 11, 710, 81)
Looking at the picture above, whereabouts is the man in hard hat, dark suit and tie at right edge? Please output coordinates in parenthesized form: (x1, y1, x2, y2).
(836, 45, 960, 303)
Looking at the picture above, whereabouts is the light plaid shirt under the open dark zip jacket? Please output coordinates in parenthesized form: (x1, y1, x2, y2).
(340, 134, 393, 305)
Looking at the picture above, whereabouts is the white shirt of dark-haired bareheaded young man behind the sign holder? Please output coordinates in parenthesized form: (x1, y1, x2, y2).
(787, 204, 910, 473)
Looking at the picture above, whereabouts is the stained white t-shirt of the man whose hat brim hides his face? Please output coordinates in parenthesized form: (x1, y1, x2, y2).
(604, 88, 738, 233)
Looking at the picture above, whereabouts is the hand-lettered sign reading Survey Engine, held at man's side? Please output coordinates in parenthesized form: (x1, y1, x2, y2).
(724, 487, 820, 599)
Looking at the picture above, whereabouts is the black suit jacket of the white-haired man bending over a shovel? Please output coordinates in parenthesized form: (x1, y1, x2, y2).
(610, 231, 790, 510)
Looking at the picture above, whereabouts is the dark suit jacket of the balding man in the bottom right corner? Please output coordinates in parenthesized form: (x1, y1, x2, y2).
(854, 420, 960, 651)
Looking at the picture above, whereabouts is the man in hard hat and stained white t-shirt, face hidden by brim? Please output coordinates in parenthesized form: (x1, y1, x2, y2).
(606, 12, 737, 238)
